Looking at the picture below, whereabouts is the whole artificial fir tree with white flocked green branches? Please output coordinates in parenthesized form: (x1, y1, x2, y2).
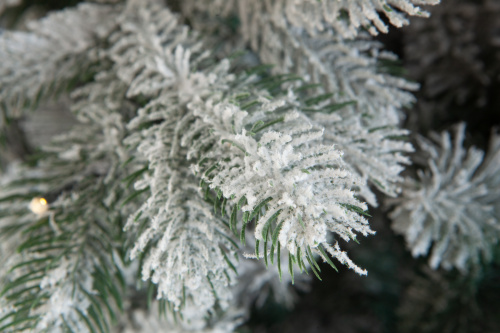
(0, 0, 500, 332)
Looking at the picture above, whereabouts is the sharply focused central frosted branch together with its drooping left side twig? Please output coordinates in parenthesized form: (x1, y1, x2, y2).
(111, 0, 372, 310)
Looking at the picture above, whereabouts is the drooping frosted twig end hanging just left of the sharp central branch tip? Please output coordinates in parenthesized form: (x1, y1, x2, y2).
(123, 169, 236, 313)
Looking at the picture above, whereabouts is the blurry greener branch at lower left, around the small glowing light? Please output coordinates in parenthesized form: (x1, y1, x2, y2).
(0, 63, 134, 332)
